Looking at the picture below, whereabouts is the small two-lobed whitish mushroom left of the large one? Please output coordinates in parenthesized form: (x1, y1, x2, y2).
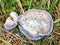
(4, 12, 18, 30)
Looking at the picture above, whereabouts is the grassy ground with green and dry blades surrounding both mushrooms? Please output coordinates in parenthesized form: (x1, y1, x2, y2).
(0, 0, 60, 45)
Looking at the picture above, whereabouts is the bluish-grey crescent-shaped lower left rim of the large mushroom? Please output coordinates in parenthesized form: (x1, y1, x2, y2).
(18, 25, 43, 40)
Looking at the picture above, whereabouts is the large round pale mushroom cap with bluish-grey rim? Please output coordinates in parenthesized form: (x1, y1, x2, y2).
(18, 9, 53, 40)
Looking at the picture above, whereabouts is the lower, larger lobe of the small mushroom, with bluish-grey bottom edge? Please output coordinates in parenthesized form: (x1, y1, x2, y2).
(4, 17, 17, 30)
